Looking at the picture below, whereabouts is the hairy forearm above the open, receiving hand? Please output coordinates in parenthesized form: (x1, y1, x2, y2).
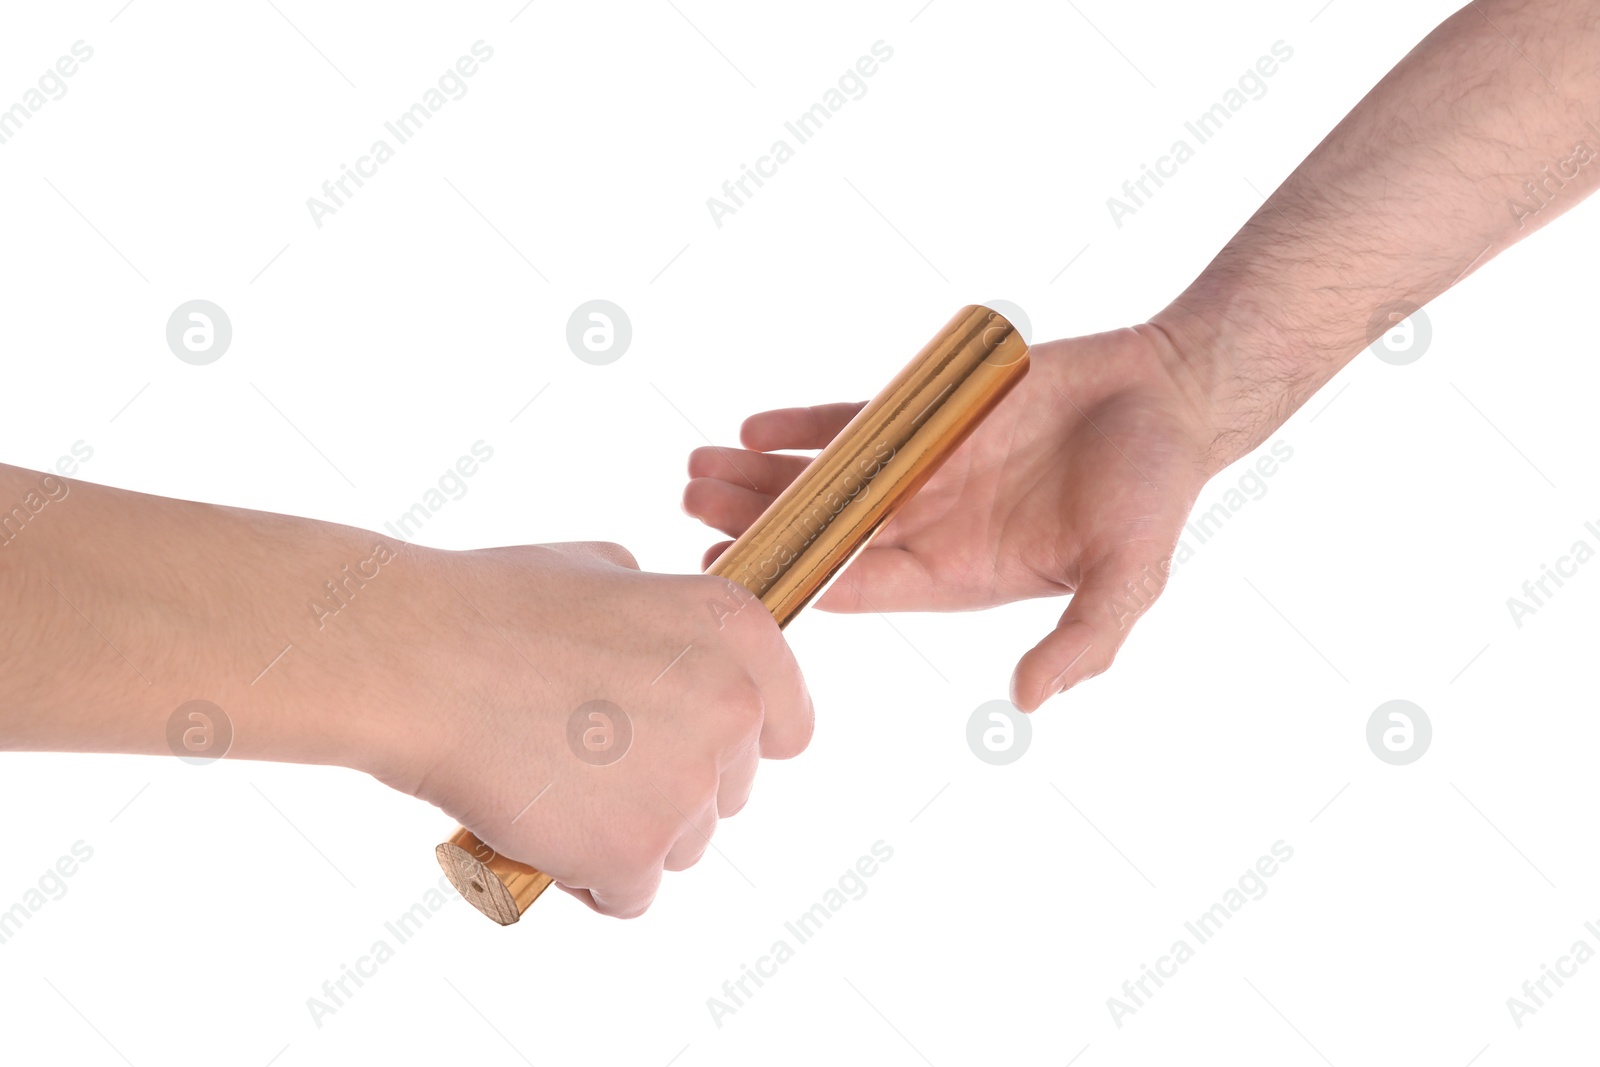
(1152, 0, 1600, 470)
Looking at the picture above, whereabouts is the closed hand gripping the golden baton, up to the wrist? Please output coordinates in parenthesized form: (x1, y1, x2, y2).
(379, 544, 813, 918)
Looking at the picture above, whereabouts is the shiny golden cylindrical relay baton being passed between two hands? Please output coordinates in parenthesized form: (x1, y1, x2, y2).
(435, 304, 1027, 926)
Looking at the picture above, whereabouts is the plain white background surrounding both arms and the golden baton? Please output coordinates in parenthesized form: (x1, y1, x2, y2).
(0, 0, 1600, 1067)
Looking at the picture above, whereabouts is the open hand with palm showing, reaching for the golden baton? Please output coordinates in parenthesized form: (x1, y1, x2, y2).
(683, 326, 1214, 710)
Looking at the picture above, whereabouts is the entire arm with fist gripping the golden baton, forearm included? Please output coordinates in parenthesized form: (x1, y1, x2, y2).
(0, 466, 811, 915)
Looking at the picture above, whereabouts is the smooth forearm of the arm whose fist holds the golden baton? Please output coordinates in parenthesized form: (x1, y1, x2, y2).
(0, 467, 444, 771)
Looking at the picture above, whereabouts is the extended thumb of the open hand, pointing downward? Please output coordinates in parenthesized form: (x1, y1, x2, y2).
(1011, 545, 1171, 712)
